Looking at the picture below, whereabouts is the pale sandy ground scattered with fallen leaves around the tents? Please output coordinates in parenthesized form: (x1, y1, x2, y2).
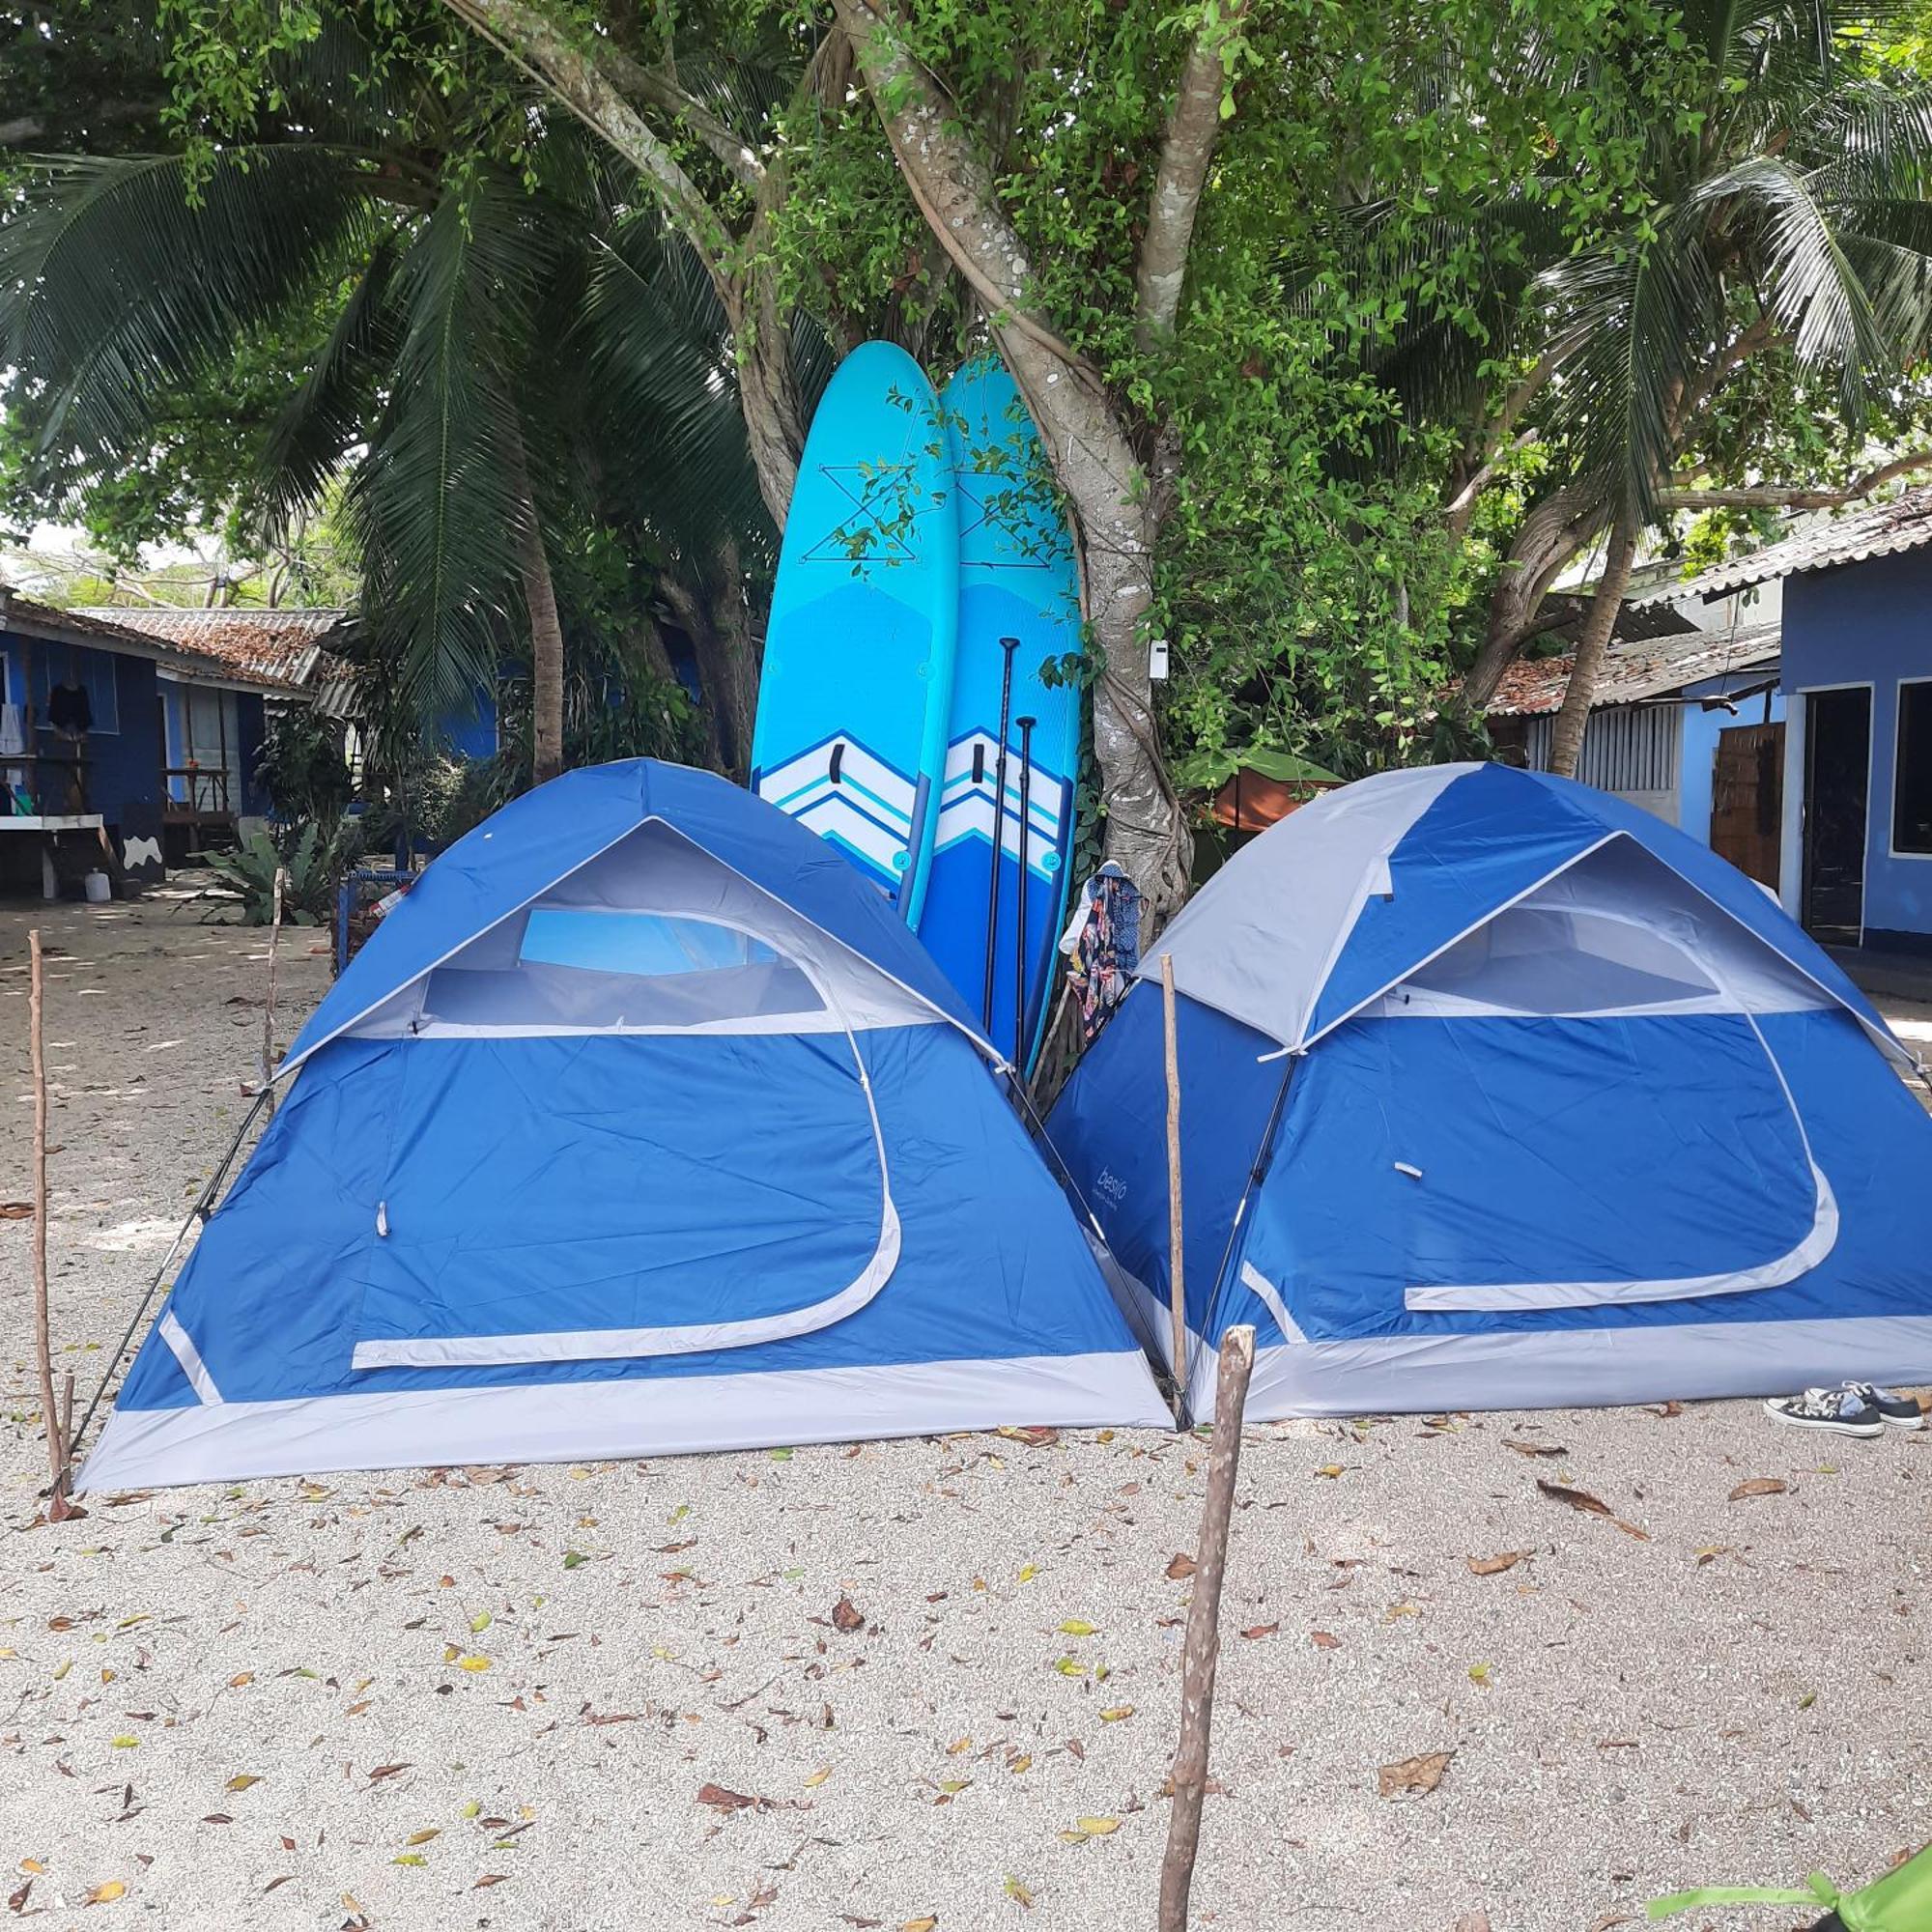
(0, 902, 1932, 1932)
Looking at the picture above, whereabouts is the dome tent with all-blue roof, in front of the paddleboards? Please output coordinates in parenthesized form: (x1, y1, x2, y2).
(81, 759, 1171, 1490)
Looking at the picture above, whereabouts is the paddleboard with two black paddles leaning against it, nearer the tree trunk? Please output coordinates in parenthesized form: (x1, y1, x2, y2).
(918, 357, 1082, 1066)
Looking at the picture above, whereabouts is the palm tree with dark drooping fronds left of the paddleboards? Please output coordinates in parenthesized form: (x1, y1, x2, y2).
(0, 12, 771, 781)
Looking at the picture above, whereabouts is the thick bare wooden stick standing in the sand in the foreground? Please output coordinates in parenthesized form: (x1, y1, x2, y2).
(1159, 1325, 1254, 1932)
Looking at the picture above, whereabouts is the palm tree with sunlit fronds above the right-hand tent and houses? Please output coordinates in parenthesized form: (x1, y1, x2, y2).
(1464, 0, 1932, 775)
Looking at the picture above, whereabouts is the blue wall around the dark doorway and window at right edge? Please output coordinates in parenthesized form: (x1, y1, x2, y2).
(1783, 551, 1932, 939)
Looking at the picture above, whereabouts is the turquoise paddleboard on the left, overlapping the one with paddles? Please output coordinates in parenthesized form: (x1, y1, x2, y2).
(752, 342, 958, 920)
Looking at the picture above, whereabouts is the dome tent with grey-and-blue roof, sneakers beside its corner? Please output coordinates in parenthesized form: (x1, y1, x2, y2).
(1047, 765, 1932, 1416)
